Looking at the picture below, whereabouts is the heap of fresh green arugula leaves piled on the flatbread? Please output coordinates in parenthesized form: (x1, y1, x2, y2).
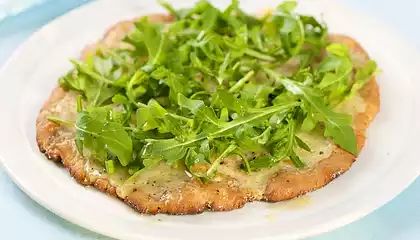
(49, 0, 377, 176)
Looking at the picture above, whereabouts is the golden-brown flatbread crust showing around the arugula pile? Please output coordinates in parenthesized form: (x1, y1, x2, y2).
(36, 15, 379, 214)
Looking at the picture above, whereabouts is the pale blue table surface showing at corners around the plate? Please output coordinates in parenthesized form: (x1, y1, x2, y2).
(0, 0, 420, 240)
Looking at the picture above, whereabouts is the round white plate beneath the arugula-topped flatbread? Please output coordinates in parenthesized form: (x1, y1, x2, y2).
(0, 0, 420, 240)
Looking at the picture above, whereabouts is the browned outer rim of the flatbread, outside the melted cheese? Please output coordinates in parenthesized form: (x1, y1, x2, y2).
(36, 15, 379, 214)
